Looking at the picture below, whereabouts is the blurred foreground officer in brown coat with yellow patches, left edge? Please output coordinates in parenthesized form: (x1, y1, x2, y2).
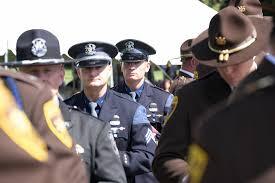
(0, 69, 87, 183)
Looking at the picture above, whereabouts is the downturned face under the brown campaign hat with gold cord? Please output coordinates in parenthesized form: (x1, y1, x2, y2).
(217, 59, 256, 87)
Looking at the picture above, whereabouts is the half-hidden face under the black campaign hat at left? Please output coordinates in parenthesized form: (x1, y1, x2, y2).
(19, 64, 65, 93)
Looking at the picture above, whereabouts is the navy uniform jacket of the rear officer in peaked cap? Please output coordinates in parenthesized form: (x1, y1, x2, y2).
(113, 81, 173, 132)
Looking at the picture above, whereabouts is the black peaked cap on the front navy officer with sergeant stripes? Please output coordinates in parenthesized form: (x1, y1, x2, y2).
(68, 41, 118, 68)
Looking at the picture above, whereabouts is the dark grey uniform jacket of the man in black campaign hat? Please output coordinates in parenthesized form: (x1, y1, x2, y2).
(59, 101, 126, 183)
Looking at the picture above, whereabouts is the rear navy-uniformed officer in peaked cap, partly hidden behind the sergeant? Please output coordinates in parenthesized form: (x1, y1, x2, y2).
(114, 39, 173, 132)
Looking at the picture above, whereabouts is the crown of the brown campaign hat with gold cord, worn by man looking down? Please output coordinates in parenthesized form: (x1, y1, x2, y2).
(208, 7, 257, 50)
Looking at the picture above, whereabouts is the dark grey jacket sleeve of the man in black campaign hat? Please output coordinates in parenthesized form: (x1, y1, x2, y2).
(94, 123, 126, 183)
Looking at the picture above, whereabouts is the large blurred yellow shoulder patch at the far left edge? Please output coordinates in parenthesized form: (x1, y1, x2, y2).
(0, 81, 48, 162)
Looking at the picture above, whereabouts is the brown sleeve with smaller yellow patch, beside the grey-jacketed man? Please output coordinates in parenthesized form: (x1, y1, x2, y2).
(24, 84, 88, 183)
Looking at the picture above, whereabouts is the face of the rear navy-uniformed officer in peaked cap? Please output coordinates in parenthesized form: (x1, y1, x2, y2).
(121, 60, 150, 82)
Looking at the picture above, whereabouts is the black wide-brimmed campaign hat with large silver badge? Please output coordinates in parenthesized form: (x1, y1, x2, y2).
(2, 29, 69, 67)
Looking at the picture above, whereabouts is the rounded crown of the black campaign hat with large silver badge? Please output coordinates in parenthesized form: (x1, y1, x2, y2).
(16, 29, 61, 61)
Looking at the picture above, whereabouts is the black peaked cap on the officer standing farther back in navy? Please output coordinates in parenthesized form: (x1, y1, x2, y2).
(116, 39, 156, 62)
